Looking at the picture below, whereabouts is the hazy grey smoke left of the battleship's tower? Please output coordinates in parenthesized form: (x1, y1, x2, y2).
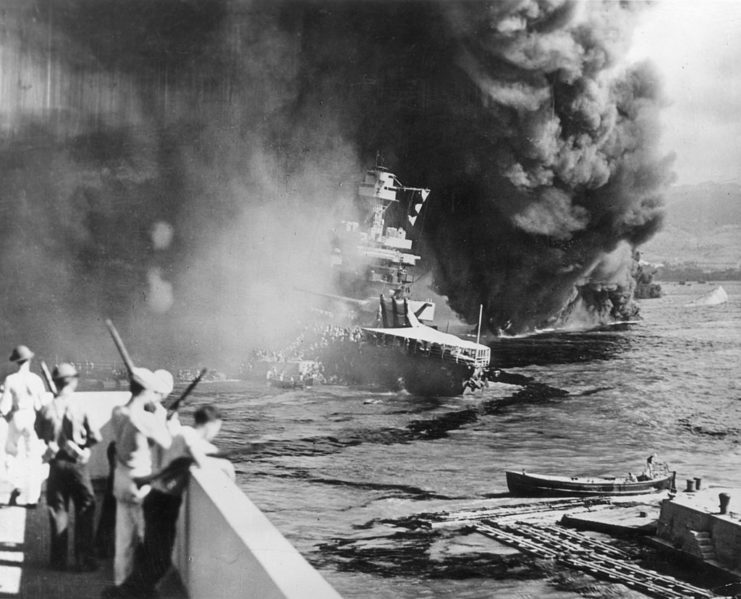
(0, 0, 361, 367)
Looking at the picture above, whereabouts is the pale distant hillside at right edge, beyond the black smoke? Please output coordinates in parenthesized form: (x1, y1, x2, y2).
(640, 182, 741, 267)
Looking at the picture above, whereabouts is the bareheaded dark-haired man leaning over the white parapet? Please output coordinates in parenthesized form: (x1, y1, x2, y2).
(110, 406, 234, 599)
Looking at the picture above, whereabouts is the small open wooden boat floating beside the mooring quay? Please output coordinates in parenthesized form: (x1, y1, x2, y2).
(506, 470, 675, 497)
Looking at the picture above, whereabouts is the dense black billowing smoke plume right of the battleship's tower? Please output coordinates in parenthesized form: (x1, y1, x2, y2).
(274, 0, 671, 332)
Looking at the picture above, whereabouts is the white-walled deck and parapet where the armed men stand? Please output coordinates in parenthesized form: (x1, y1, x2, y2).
(0, 392, 340, 599)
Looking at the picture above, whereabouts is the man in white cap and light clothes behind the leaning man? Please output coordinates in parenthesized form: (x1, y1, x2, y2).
(111, 368, 173, 585)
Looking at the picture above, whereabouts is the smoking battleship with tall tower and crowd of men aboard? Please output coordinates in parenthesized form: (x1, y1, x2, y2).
(253, 166, 491, 396)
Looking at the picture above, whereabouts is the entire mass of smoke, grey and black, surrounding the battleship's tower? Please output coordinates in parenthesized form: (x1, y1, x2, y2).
(0, 0, 669, 364)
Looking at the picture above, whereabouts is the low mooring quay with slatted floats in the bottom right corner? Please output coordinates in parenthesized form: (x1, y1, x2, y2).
(418, 489, 741, 599)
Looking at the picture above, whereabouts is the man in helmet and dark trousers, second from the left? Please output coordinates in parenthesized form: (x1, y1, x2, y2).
(37, 364, 101, 572)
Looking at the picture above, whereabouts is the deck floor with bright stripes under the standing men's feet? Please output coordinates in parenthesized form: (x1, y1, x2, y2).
(0, 480, 187, 599)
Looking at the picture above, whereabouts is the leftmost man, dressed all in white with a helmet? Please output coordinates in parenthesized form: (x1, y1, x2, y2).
(0, 345, 45, 508)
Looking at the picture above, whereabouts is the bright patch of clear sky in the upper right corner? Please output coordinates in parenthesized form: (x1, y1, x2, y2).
(630, 0, 741, 184)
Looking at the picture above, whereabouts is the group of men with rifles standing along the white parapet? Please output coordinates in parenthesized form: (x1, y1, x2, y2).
(0, 345, 234, 598)
